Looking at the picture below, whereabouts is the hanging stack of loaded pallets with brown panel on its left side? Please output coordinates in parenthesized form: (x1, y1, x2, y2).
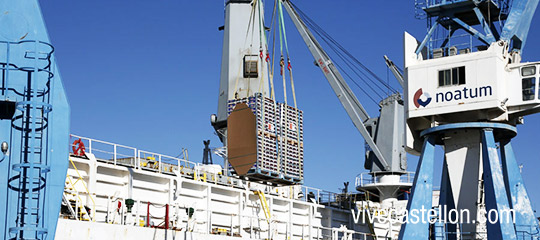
(227, 94, 304, 185)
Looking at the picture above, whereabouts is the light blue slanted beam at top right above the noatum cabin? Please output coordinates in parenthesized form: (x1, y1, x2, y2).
(501, 0, 539, 52)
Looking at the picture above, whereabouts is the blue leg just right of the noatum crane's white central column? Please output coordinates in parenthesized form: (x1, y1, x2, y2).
(482, 129, 517, 240)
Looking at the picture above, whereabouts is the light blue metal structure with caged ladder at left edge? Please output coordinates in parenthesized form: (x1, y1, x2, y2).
(0, 0, 69, 240)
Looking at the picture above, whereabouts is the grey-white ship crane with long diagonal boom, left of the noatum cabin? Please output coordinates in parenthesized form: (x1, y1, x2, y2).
(283, 0, 410, 206)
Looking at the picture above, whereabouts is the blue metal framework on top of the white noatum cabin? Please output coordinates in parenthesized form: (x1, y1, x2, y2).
(415, 0, 540, 55)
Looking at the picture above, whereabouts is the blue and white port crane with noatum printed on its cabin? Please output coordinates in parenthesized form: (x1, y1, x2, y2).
(399, 0, 540, 240)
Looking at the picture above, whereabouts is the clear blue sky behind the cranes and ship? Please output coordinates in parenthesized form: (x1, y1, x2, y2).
(41, 0, 540, 214)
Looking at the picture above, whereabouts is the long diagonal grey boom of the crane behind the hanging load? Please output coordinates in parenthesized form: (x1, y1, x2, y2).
(283, 0, 389, 169)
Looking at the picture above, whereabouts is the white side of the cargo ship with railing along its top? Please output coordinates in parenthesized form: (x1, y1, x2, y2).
(56, 136, 371, 239)
